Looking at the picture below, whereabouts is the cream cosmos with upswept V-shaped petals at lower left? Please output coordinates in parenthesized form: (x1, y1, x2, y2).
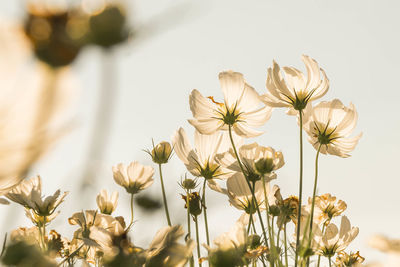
(6, 176, 68, 222)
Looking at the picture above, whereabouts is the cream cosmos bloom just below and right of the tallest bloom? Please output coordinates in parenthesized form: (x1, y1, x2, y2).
(304, 99, 362, 158)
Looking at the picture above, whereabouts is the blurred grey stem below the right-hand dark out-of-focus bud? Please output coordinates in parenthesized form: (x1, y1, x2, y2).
(81, 50, 118, 190)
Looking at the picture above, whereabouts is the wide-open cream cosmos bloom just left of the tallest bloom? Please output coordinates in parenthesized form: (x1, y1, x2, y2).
(189, 71, 272, 137)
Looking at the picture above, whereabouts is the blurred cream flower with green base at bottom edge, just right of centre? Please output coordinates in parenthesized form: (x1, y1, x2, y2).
(203, 221, 248, 267)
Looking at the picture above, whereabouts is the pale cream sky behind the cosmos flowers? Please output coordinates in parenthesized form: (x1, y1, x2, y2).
(0, 0, 400, 264)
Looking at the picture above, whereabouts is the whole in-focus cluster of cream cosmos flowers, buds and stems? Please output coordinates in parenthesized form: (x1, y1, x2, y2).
(2, 56, 364, 267)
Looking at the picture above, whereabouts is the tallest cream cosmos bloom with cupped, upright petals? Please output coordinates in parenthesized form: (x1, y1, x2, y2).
(261, 55, 329, 115)
